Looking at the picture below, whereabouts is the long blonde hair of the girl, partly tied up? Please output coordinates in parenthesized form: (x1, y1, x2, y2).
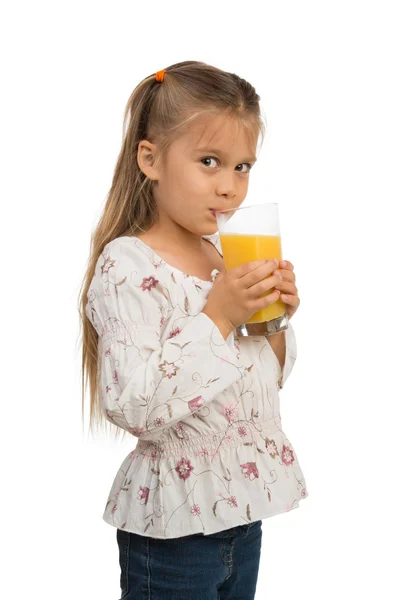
(78, 61, 265, 438)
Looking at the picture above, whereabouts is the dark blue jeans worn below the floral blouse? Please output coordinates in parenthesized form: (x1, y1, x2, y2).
(117, 520, 262, 600)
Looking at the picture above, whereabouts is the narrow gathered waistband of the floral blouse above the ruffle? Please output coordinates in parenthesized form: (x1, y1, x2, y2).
(132, 415, 282, 459)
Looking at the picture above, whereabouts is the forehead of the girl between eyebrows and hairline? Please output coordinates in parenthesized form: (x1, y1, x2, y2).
(180, 114, 257, 154)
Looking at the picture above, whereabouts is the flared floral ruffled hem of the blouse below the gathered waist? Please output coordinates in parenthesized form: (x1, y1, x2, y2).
(103, 428, 308, 539)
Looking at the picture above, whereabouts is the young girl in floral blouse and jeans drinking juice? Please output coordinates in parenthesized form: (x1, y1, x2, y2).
(81, 61, 308, 600)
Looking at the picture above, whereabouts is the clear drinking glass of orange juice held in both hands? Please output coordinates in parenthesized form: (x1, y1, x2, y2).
(215, 202, 288, 336)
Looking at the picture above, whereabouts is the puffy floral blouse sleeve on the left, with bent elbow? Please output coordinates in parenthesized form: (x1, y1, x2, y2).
(86, 238, 244, 439)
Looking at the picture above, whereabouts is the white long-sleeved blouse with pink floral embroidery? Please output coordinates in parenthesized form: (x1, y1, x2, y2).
(86, 232, 308, 539)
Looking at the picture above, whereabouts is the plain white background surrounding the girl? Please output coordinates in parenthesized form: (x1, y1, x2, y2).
(0, 0, 400, 600)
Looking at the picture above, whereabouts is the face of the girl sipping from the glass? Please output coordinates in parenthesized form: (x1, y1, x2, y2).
(153, 115, 257, 236)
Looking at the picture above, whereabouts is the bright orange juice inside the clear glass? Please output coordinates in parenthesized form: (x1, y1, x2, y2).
(220, 233, 286, 323)
